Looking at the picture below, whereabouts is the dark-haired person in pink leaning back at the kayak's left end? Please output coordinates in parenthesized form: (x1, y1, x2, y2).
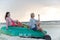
(5, 12, 23, 29)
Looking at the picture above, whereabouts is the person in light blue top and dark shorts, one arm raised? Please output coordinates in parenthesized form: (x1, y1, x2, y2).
(29, 13, 43, 31)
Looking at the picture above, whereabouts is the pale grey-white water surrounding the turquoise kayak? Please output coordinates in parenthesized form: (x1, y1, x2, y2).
(0, 22, 60, 40)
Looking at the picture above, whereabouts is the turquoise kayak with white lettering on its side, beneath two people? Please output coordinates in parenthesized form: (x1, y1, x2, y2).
(0, 26, 47, 38)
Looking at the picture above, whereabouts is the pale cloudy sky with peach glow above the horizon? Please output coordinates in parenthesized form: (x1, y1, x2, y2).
(0, 0, 60, 22)
